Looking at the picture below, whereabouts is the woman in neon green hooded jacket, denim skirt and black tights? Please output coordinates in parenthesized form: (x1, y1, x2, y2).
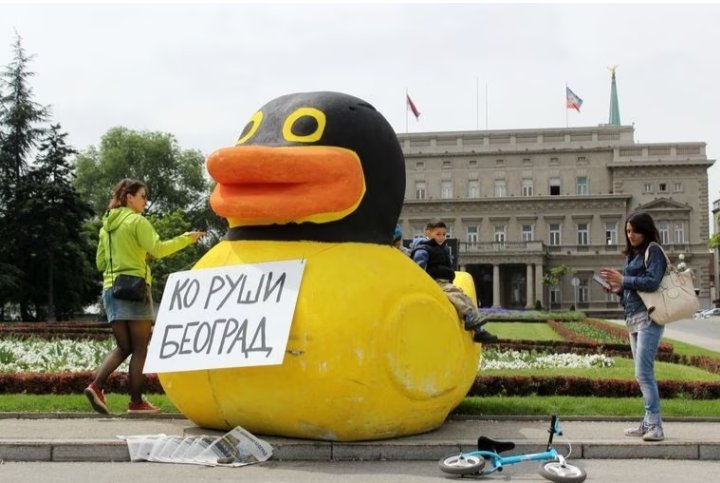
(85, 179, 205, 414)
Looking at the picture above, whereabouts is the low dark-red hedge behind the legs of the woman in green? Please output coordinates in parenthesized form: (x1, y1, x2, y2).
(0, 371, 164, 394)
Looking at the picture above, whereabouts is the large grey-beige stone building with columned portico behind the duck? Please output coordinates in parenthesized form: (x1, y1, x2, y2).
(398, 125, 714, 314)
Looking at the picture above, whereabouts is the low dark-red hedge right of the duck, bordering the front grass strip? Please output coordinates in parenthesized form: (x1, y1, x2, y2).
(468, 376, 720, 399)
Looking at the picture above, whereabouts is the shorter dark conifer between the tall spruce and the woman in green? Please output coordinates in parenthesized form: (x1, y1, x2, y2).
(4, 125, 100, 321)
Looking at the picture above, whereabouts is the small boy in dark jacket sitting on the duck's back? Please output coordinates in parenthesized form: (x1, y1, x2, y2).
(412, 220, 498, 343)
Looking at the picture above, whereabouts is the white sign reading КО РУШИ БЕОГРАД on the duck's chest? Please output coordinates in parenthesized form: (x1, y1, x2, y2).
(143, 260, 305, 373)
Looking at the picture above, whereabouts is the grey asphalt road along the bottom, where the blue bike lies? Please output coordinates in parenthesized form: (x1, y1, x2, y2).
(0, 459, 720, 483)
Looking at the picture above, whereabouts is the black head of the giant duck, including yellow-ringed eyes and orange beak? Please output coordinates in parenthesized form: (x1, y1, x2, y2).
(208, 92, 405, 244)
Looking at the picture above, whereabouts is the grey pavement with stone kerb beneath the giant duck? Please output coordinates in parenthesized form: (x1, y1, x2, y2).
(0, 414, 720, 462)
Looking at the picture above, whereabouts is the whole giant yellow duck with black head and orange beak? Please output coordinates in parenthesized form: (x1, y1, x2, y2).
(159, 92, 480, 441)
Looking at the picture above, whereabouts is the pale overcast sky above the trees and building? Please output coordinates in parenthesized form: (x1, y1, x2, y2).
(0, 3, 720, 225)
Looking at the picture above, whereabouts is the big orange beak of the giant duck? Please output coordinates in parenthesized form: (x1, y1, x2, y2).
(207, 146, 365, 227)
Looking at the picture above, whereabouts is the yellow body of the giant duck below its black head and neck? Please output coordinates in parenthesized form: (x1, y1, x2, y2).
(159, 240, 481, 441)
